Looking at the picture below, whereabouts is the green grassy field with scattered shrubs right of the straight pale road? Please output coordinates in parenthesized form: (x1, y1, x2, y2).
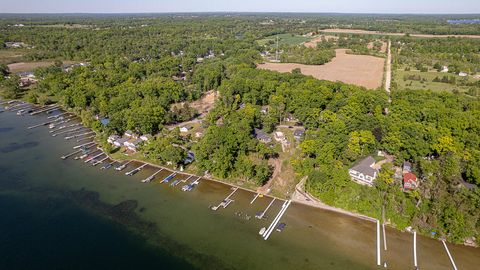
(393, 70, 476, 92)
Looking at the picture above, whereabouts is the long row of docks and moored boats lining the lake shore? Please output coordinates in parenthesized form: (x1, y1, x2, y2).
(0, 100, 464, 270)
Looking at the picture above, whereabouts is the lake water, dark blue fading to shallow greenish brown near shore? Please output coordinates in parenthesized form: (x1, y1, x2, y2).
(0, 108, 480, 269)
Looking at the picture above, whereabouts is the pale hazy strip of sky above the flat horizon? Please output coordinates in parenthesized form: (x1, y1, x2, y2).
(0, 0, 480, 14)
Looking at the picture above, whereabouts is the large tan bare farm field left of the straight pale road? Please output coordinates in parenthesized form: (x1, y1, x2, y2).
(257, 49, 385, 89)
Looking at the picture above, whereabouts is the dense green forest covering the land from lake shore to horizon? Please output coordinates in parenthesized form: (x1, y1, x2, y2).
(0, 15, 480, 243)
